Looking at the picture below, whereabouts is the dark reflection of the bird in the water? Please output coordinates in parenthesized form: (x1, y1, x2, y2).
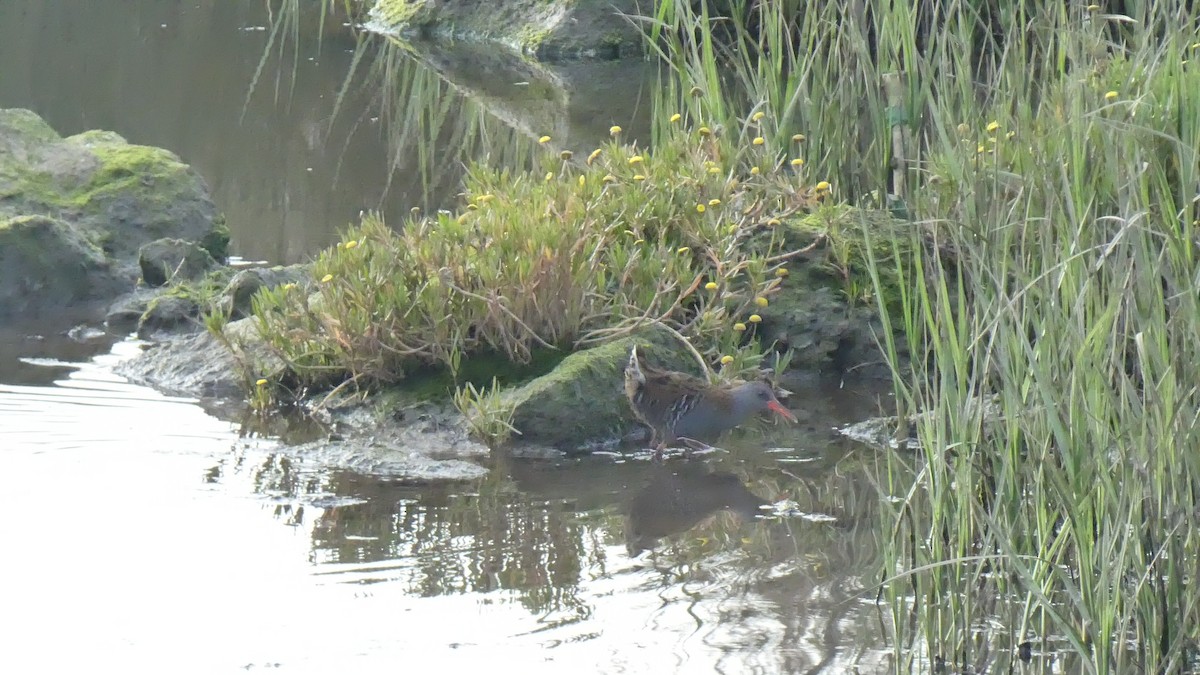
(625, 465, 769, 556)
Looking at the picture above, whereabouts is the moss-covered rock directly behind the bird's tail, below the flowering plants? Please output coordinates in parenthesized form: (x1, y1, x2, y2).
(504, 328, 700, 450)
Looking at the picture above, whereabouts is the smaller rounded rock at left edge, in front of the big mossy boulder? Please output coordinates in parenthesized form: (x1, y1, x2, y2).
(0, 215, 125, 318)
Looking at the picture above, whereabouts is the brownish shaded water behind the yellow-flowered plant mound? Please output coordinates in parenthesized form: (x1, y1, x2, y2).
(0, 0, 655, 263)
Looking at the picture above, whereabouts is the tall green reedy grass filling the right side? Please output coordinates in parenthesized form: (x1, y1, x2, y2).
(655, 0, 1200, 673)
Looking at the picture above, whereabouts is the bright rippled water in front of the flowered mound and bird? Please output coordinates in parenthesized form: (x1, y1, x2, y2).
(0, 335, 887, 673)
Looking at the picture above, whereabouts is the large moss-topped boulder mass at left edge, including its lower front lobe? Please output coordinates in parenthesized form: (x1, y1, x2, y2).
(0, 109, 229, 316)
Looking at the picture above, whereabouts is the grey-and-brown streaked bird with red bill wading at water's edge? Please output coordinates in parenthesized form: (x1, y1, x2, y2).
(625, 345, 796, 460)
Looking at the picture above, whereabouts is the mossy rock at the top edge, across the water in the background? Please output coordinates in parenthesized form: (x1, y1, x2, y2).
(367, 0, 643, 60)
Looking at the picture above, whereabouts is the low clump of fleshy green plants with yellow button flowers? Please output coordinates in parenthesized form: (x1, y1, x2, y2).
(240, 124, 824, 389)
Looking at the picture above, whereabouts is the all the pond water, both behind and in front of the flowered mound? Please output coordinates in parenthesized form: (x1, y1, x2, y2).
(0, 0, 889, 674)
